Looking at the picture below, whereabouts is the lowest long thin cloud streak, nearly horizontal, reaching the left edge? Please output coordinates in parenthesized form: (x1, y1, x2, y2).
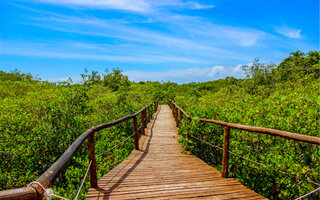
(0, 41, 208, 64)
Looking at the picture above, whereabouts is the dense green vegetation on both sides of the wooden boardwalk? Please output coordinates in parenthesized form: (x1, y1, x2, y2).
(0, 51, 320, 199)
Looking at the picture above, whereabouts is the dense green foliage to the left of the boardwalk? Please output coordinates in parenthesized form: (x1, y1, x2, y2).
(0, 70, 154, 199)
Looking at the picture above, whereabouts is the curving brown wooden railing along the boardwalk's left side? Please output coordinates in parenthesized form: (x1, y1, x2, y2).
(0, 101, 158, 200)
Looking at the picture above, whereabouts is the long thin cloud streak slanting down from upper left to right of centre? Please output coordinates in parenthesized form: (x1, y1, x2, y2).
(25, 12, 230, 54)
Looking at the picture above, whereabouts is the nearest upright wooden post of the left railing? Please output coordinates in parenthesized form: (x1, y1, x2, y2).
(87, 132, 98, 188)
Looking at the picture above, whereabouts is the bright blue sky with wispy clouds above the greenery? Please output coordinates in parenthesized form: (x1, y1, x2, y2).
(0, 0, 319, 83)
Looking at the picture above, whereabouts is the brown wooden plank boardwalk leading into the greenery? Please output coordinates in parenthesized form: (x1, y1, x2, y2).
(87, 105, 266, 199)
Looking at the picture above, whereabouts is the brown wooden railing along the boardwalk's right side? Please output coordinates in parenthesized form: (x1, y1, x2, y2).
(168, 99, 320, 178)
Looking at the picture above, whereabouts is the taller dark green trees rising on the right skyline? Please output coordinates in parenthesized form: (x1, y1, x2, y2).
(242, 51, 320, 96)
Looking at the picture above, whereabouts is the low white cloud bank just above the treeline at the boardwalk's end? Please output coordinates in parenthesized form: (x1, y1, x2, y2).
(124, 65, 244, 83)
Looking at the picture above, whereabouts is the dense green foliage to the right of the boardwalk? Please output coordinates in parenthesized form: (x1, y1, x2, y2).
(174, 52, 320, 199)
